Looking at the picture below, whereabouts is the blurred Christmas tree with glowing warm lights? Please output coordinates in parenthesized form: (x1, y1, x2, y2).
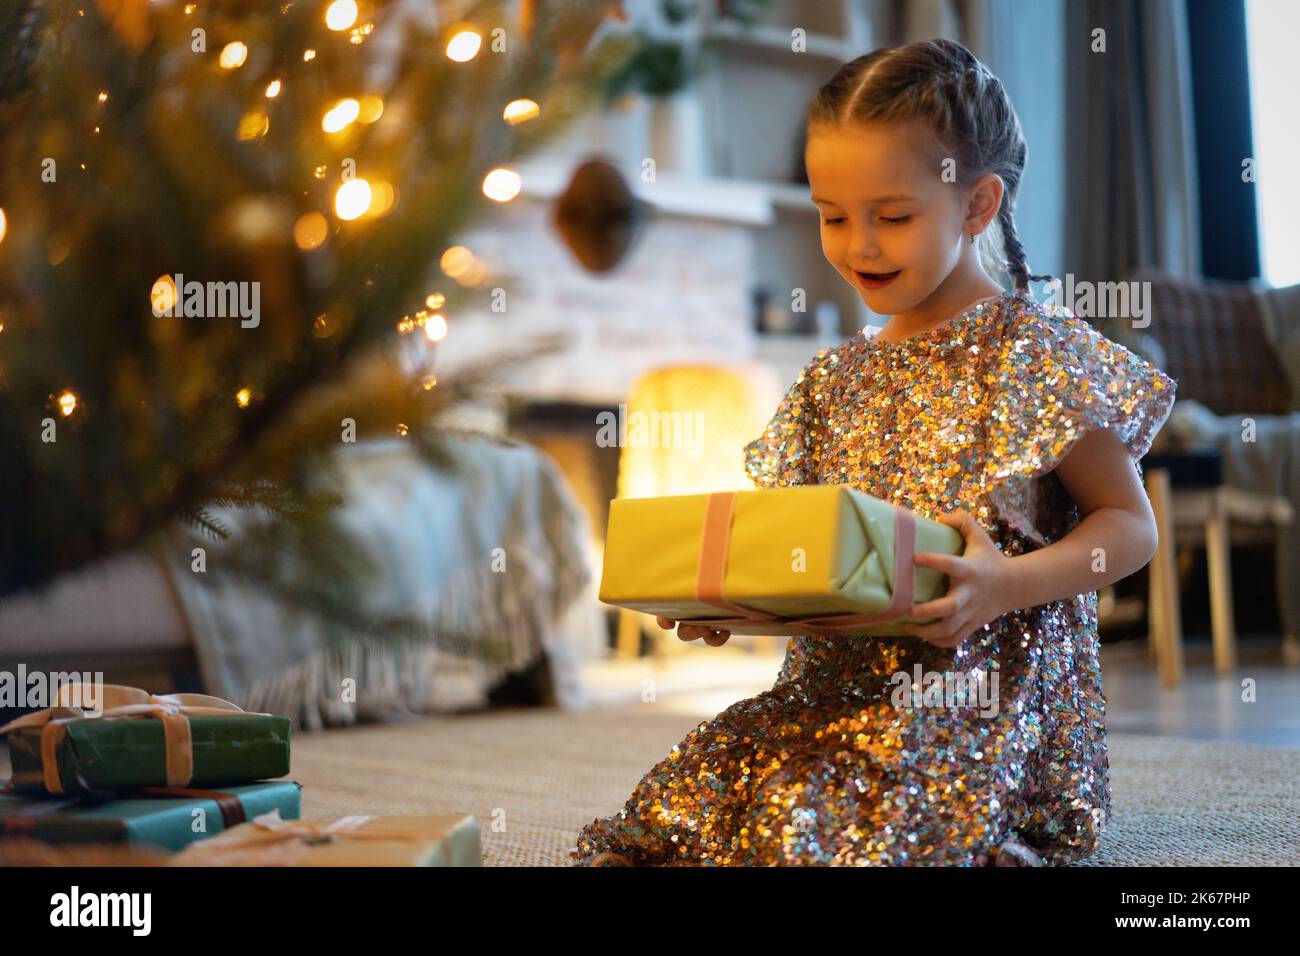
(0, 0, 631, 647)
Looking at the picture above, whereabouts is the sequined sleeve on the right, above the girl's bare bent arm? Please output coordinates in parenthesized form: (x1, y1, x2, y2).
(984, 308, 1177, 509)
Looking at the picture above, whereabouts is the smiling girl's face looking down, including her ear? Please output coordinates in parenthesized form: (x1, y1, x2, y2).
(805, 124, 1001, 315)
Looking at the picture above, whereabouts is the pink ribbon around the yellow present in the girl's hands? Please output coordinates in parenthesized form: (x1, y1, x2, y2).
(688, 492, 917, 636)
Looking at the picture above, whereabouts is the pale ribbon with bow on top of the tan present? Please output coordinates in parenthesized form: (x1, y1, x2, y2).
(177, 809, 447, 866)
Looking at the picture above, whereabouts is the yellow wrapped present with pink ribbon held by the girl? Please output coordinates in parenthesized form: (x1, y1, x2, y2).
(601, 485, 963, 636)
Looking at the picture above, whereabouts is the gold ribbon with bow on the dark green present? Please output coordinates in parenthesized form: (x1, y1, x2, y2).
(0, 684, 270, 793)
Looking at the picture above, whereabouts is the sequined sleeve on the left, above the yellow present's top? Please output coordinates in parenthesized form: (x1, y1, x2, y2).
(745, 350, 831, 488)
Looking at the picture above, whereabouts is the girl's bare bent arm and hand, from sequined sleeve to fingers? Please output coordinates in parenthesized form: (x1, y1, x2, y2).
(907, 428, 1156, 646)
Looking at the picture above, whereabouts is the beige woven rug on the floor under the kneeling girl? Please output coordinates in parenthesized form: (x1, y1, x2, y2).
(276, 704, 1300, 866)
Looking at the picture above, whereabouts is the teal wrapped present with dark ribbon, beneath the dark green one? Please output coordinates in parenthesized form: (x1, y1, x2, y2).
(0, 780, 302, 851)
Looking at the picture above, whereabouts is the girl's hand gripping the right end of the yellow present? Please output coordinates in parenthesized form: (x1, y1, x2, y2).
(906, 510, 1014, 648)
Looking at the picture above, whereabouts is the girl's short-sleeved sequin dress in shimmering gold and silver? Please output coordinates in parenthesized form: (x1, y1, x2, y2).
(571, 291, 1175, 866)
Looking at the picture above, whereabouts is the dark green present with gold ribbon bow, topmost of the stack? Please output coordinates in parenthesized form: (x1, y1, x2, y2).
(0, 684, 290, 795)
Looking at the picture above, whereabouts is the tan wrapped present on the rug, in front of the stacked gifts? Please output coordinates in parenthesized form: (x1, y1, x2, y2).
(172, 813, 482, 866)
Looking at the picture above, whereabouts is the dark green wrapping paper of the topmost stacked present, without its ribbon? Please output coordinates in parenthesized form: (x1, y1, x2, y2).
(8, 714, 290, 795)
